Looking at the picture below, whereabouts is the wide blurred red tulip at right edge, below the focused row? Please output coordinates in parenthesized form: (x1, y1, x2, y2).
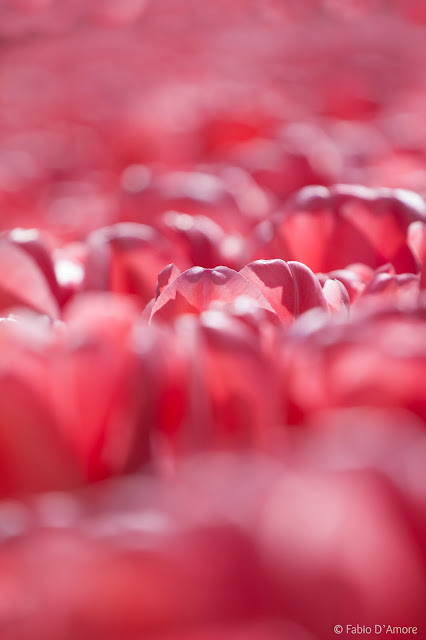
(279, 305, 426, 423)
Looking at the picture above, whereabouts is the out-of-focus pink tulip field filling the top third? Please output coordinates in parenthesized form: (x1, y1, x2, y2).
(0, 0, 426, 239)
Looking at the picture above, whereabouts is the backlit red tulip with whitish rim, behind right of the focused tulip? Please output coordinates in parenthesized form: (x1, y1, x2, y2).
(256, 186, 425, 273)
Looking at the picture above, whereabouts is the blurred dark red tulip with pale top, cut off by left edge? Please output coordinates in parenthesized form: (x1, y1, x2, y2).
(0, 314, 84, 499)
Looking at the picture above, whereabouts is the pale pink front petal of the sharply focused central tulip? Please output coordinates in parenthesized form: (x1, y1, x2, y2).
(151, 267, 273, 320)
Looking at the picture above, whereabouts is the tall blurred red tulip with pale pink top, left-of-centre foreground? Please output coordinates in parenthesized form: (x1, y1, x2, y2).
(49, 294, 150, 480)
